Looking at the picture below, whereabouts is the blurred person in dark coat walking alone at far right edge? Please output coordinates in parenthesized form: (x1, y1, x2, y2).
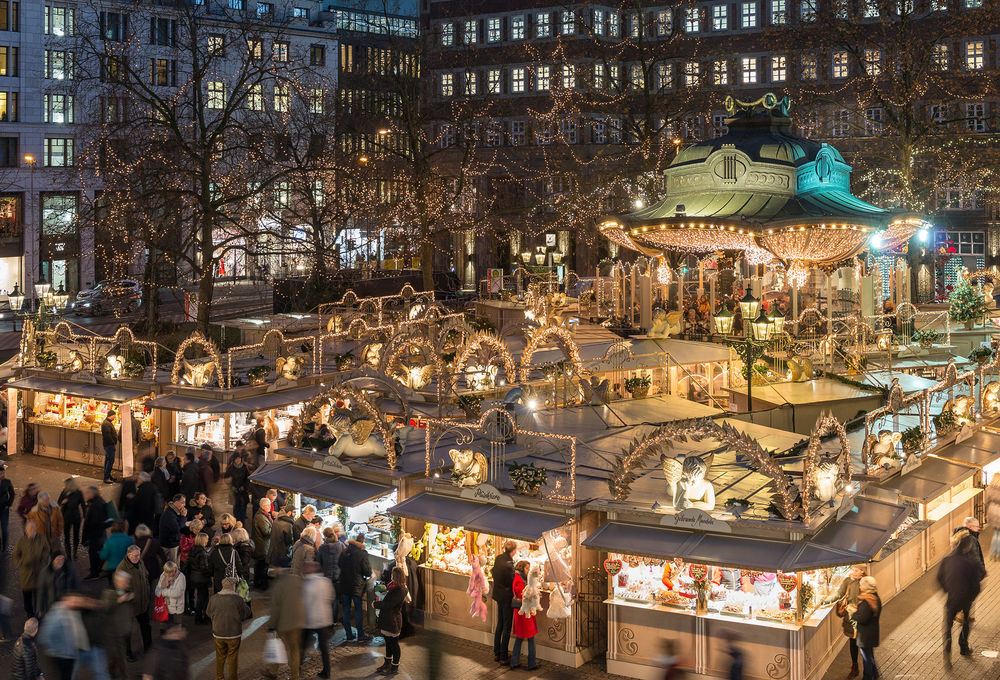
(936, 528, 986, 667)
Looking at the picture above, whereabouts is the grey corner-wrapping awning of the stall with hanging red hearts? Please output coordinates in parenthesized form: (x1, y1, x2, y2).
(583, 498, 909, 571)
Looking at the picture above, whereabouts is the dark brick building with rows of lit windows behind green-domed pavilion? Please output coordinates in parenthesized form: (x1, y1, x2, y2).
(422, 0, 1000, 292)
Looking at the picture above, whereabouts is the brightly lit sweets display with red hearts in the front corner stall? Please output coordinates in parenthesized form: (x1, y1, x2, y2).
(605, 553, 850, 623)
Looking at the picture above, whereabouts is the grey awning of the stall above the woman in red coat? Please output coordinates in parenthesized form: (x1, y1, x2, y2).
(389, 491, 569, 541)
